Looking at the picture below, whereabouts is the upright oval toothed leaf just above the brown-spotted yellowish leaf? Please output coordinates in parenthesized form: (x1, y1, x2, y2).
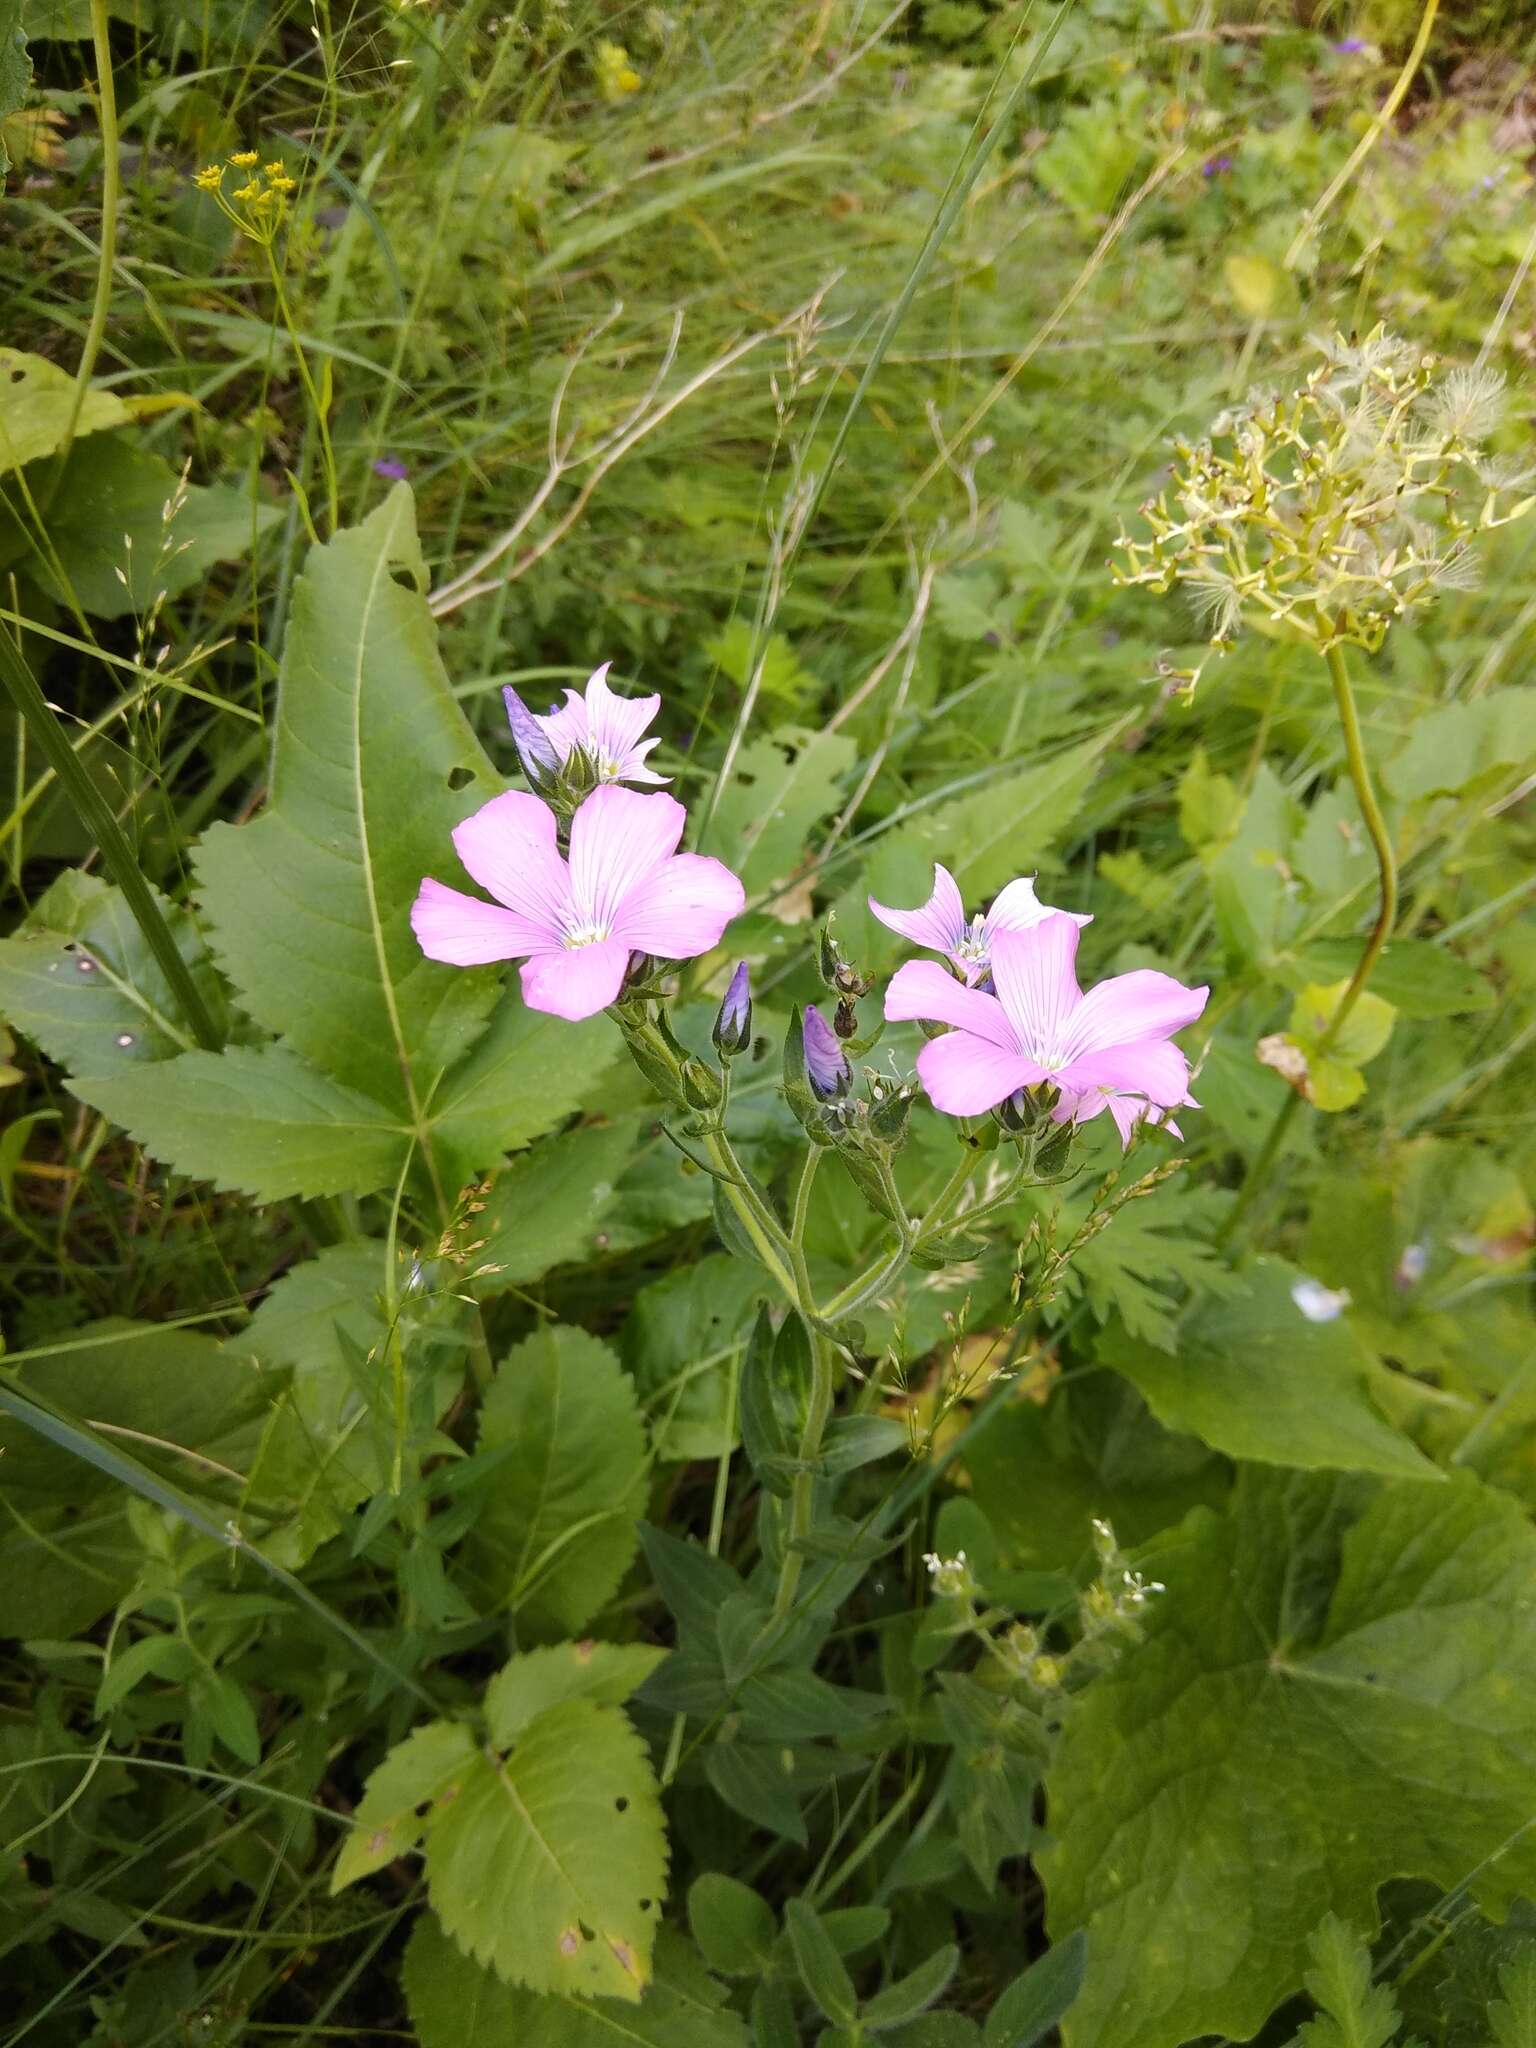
(475, 1325, 649, 1630)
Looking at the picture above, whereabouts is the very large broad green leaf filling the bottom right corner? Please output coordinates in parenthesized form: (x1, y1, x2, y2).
(1040, 1468, 1536, 2048)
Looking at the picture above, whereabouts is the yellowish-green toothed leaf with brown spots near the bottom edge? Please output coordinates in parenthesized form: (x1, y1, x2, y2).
(426, 1700, 668, 1999)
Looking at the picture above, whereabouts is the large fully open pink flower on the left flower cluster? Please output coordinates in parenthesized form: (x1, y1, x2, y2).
(412, 788, 745, 1022)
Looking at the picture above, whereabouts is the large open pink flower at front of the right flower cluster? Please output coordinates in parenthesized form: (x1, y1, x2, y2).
(885, 911, 1210, 1145)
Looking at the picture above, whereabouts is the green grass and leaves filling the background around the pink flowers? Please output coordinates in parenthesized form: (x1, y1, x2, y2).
(0, 0, 1536, 2048)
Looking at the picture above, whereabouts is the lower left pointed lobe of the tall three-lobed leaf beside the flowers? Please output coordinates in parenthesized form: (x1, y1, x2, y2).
(74, 1044, 412, 1202)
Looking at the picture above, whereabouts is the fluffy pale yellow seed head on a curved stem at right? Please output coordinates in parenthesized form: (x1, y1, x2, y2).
(1114, 328, 1536, 688)
